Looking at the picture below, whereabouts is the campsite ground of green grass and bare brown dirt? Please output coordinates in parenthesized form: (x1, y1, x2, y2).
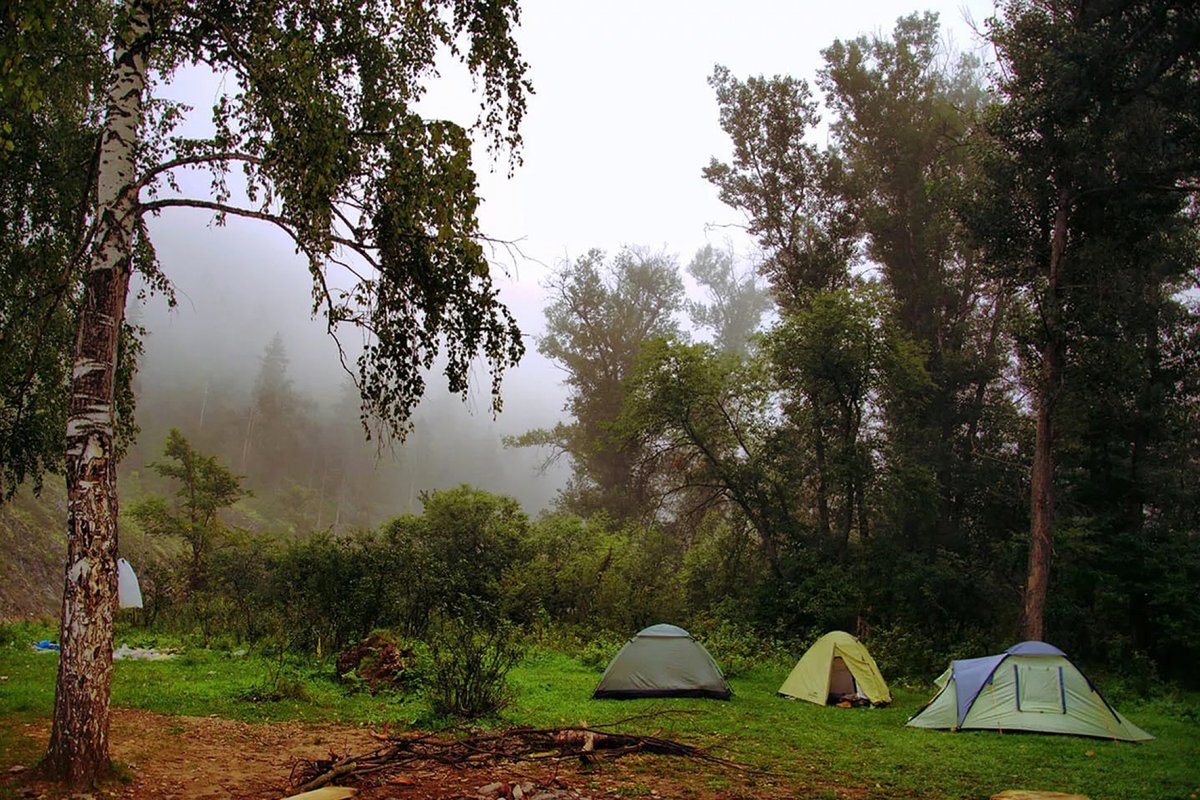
(0, 628, 1200, 800)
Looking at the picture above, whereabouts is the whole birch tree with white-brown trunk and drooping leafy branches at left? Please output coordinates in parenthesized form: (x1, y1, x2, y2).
(5, 0, 530, 786)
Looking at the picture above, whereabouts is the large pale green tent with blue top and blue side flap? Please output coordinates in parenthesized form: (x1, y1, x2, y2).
(908, 642, 1153, 741)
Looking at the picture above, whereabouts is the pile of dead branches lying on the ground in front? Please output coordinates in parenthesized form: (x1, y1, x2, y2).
(292, 715, 743, 792)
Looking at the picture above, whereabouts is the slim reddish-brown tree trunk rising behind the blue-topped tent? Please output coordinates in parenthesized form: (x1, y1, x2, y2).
(1022, 190, 1069, 640)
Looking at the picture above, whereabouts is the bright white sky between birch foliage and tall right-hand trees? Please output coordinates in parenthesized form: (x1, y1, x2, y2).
(446, 0, 992, 332)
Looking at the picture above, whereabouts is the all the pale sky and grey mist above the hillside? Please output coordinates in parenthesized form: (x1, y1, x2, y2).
(124, 0, 986, 527)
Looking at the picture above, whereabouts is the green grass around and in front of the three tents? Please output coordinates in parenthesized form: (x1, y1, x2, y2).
(505, 655, 1200, 800)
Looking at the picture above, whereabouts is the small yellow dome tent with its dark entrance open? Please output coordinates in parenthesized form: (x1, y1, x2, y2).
(779, 631, 892, 705)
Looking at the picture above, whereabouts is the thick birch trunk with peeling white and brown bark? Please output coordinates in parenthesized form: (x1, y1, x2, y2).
(46, 2, 149, 787)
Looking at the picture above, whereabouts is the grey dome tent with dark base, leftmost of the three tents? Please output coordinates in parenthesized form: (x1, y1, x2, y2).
(592, 625, 733, 700)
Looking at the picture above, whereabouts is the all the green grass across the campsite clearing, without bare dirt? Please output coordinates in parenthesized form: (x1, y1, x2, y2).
(0, 630, 1200, 800)
